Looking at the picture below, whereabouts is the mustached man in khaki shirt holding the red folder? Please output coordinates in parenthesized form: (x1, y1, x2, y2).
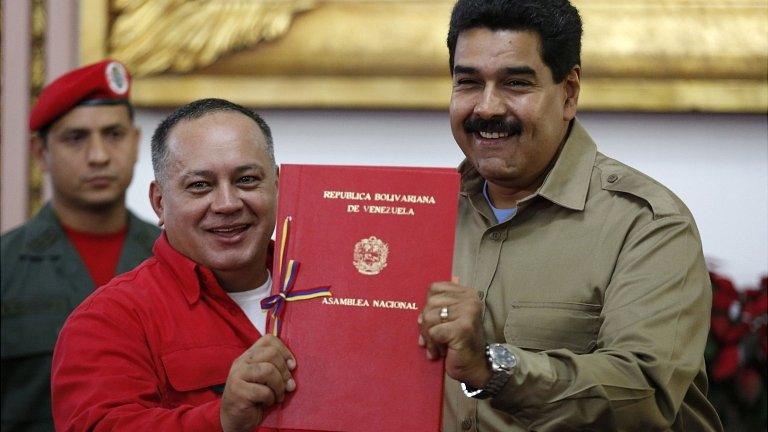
(419, 0, 722, 432)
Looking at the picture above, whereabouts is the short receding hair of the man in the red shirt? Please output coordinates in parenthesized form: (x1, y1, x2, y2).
(152, 98, 277, 181)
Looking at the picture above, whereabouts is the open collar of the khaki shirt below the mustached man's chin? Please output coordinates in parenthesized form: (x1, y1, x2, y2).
(459, 119, 597, 211)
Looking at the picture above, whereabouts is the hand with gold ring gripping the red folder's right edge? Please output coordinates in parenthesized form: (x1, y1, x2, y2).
(419, 282, 491, 388)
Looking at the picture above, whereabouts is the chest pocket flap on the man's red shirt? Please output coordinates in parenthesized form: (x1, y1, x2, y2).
(161, 345, 245, 392)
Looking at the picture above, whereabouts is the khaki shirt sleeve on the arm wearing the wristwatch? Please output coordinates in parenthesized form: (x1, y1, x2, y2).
(491, 216, 712, 431)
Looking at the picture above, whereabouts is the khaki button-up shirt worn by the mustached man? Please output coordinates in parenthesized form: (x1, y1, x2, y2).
(444, 121, 722, 432)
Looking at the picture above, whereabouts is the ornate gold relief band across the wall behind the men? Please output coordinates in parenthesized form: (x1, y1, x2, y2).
(80, 0, 768, 112)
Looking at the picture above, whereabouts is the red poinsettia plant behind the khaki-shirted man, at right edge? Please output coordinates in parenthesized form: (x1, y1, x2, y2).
(706, 272, 768, 430)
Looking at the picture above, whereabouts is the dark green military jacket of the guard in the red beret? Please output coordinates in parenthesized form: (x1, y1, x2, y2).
(0, 204, 160, 431)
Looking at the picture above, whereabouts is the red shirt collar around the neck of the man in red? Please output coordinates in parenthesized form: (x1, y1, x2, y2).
(152, 231, 274, 304)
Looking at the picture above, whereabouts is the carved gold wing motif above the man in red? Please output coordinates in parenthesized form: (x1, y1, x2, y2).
(109, 0, 317, 77)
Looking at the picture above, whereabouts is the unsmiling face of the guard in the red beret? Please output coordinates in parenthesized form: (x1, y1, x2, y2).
(33, 105, 139, 211)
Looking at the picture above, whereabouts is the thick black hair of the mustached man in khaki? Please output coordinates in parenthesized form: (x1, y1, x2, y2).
(448, 0, 582, 83)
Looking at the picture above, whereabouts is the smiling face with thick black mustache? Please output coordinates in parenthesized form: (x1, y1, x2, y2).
(450, 27, 579, 199)
